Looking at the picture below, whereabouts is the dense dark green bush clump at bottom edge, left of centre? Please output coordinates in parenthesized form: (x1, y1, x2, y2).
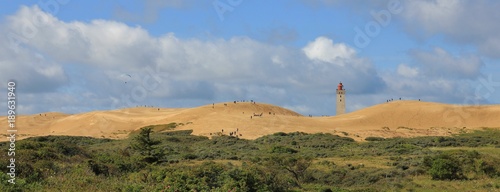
(154, 161, 291, 191)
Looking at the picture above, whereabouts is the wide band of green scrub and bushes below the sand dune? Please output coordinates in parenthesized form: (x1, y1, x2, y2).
(0, 128, 500, 191)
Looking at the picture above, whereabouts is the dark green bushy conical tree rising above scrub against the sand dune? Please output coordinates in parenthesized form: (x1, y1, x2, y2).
(131, 127, 163, 163)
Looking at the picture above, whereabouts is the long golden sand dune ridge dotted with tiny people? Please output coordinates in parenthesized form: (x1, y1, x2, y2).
(0, 101, 500, 141)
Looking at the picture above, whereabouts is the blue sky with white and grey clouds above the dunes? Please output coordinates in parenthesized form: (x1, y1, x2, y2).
(0, 0, 500, 115)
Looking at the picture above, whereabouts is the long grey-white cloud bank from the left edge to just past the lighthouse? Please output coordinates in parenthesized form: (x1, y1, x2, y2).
(0, 6, 385, 113)
